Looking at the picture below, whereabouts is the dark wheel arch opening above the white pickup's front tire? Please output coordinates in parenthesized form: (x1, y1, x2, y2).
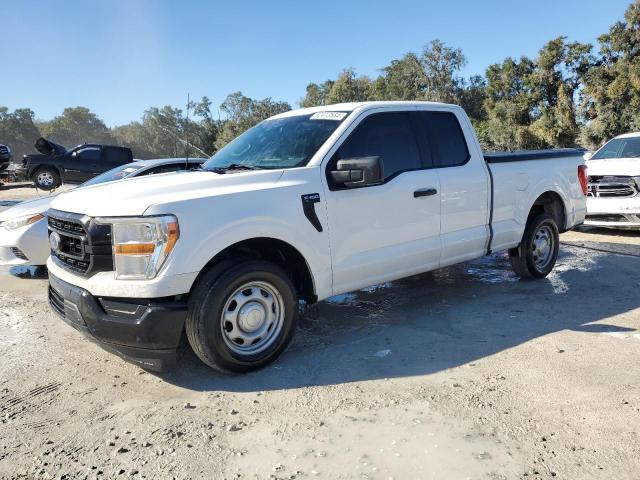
(191, 237, 317, 303)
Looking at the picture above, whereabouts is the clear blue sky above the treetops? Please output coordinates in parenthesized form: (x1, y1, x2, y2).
(0, 0, 629, 127)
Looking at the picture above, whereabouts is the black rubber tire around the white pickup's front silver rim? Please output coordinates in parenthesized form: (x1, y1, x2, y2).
(186, 260, 298, 372)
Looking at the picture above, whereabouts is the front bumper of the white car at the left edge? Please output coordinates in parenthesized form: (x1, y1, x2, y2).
(0, 219, 50, 266)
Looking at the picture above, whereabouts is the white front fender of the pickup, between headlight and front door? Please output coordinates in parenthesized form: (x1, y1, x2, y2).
(146, 168, 332, 298)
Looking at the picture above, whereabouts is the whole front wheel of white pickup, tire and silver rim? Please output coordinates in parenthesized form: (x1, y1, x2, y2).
(186, 261, 298, 372)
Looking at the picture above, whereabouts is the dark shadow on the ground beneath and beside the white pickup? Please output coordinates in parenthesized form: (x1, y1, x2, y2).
(162, 247, 640, 392)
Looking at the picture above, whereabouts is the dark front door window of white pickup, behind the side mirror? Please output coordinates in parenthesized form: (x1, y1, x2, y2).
(331, 112, 422, 180)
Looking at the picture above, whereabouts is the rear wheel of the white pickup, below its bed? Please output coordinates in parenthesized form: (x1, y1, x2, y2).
(509, 213, 560, 279)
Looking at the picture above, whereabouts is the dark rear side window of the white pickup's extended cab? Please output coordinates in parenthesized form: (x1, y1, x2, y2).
(415, 112, 469, 167)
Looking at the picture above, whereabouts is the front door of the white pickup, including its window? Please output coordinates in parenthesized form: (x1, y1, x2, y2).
(323, 111, 440, 293)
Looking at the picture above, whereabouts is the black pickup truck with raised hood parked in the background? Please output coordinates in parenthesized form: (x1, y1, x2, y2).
(14, 138, 133, 190)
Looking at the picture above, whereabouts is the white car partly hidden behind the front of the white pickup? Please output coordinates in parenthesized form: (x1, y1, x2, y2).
(0, 158, 206, 265)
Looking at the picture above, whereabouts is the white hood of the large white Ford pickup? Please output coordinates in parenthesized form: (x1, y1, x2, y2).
(51, 170, 284, 217)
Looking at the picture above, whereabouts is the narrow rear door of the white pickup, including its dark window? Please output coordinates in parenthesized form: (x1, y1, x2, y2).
(414, 110, 490, 266)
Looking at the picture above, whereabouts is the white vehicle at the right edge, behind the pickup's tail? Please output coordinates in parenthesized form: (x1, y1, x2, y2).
(584, 132, 640, 229)
